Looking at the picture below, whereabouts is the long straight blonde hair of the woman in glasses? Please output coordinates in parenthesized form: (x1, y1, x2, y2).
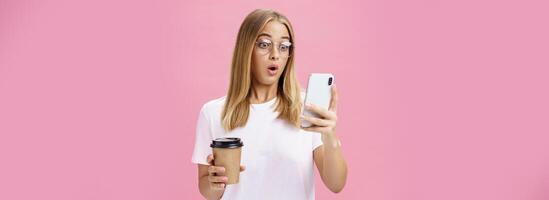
(221, 9, 303, 132)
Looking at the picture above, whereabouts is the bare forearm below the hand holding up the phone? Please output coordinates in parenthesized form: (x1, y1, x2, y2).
(322, 134, 347, 193)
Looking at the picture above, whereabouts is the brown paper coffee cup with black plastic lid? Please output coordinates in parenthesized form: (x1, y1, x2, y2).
(210, 137, 244, 184)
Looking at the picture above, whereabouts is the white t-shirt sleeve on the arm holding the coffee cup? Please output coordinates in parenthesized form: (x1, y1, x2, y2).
(191, 107, 213, 165)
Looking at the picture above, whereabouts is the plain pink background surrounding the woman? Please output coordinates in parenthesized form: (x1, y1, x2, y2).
(0, 0, 549, 200)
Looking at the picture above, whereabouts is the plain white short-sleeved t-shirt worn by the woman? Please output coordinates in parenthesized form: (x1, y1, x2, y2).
(192, 94, 322, 200)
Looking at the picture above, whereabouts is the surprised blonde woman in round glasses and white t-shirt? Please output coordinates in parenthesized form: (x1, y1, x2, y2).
(192, 10, 347, 200)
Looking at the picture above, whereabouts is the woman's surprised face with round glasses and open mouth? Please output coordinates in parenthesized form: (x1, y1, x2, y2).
(251, 21, 291, 85)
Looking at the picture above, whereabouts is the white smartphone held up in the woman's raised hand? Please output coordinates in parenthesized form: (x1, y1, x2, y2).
(301, 73, 335, 128)
